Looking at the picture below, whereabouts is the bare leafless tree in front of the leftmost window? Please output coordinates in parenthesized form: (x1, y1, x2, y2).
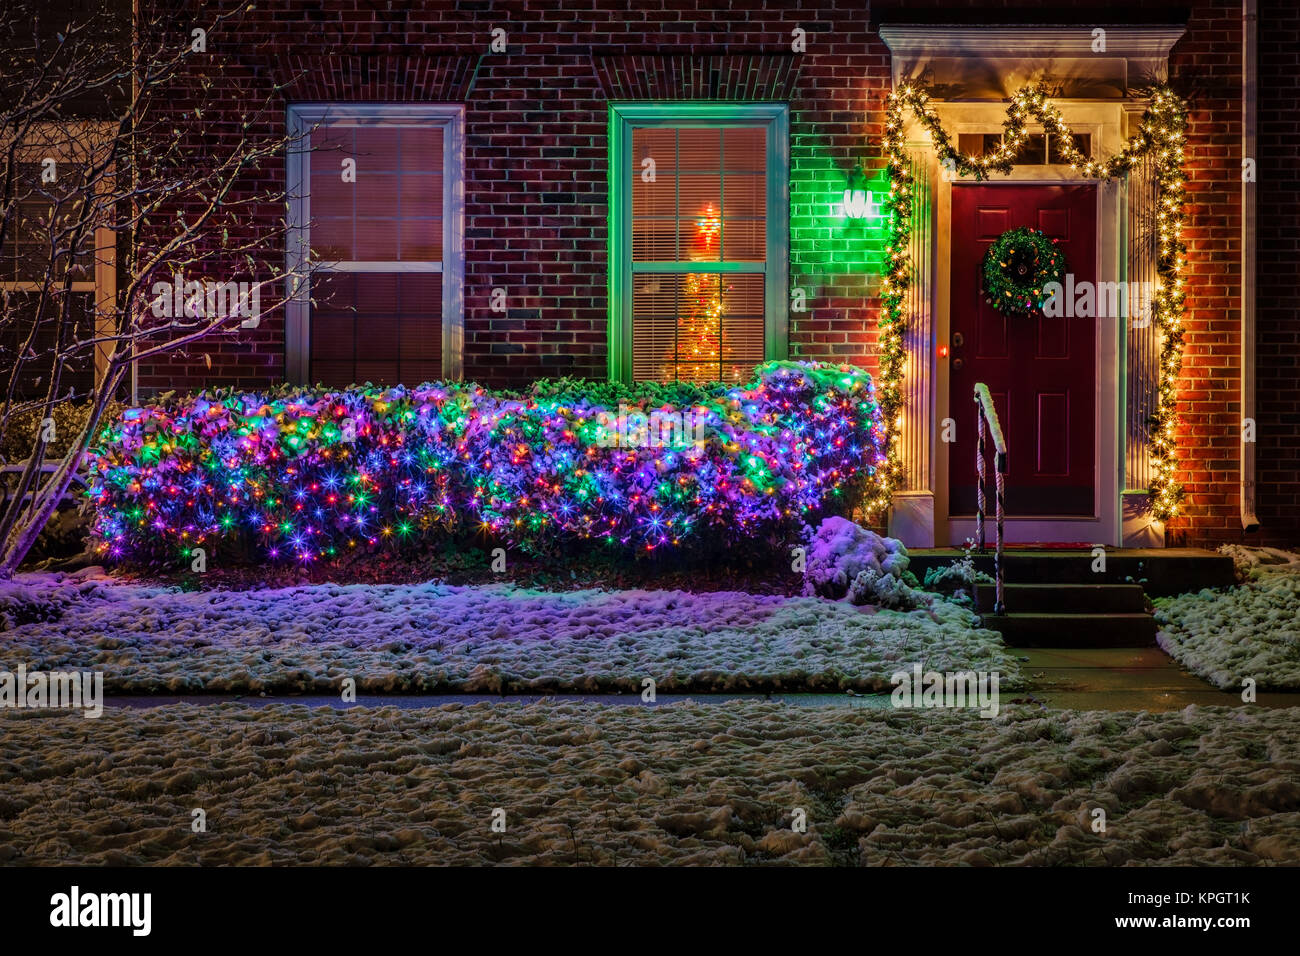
(0, 0, 306, 578)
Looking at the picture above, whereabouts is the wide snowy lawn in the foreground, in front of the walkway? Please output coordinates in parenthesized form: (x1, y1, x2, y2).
(0, 701, 1300, 865)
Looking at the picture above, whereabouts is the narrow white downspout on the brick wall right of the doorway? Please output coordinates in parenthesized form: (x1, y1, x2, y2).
(1242, 0, 1260, 531)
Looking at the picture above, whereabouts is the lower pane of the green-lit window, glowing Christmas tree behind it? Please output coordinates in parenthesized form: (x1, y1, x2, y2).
(632, 273, 764, 382)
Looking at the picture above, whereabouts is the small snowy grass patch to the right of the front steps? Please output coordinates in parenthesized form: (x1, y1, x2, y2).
(1156, 546, 1300, 691)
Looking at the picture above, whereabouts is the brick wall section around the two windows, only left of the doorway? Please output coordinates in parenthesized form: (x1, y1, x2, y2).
(139, 0, 889, 392)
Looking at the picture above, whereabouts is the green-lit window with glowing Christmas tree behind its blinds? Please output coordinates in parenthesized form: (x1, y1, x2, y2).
(610, 103, 790, 381)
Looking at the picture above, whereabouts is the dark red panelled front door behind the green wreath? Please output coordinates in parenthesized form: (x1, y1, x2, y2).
(948, 183, 1097, 519)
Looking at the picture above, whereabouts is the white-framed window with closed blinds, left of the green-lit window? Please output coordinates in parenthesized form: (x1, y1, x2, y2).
(285, 103, 464, 388)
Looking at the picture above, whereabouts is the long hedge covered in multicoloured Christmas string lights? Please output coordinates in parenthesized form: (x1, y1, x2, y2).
(88, 362, 881, 562)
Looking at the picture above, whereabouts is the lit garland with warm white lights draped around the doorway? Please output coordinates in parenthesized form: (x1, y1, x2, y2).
(871, 86, 1187, 520)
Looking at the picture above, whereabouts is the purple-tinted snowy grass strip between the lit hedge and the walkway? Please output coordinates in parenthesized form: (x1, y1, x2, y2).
(0, 570, 1021, 693)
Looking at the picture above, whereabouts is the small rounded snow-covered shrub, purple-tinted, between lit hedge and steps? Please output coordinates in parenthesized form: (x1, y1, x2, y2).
(803, 515, 922, 609)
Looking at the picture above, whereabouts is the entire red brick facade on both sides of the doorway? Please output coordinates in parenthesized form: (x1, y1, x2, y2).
(138, 0, 1300, 544)
